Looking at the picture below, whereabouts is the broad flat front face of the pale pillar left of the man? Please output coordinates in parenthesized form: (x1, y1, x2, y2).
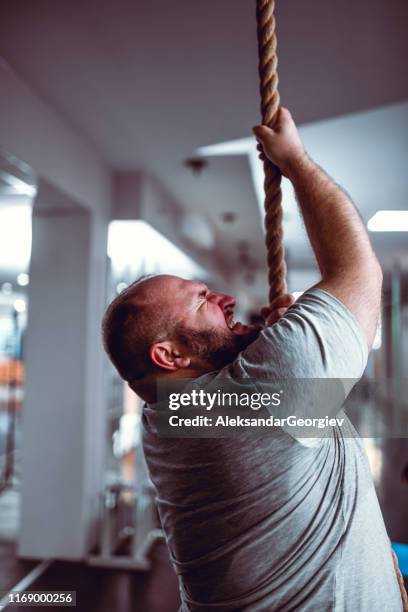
(19, 187, 91, 558)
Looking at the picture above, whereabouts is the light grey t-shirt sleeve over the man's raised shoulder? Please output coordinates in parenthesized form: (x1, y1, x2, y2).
(231, 289, 368, 388)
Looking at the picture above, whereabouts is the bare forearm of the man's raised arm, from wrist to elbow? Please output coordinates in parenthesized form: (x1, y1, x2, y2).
(288, 154, 378, 278)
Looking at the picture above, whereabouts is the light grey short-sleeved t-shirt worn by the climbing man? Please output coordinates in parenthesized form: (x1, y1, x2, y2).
(143, 289, 402, 612)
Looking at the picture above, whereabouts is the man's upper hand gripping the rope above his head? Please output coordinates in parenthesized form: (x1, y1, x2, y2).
(253, 108, 306, 178)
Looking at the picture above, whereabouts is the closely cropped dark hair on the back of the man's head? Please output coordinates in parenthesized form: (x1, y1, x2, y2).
(102, 276, 171, 383)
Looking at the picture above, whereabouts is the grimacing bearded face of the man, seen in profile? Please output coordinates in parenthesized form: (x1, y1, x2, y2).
(146, 275, 260, 369)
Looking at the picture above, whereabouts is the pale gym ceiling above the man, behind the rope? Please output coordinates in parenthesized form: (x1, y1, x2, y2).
(0, 0, 408, 286)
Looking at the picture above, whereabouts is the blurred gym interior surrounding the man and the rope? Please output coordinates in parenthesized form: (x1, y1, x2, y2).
(0, 0, 408, 612)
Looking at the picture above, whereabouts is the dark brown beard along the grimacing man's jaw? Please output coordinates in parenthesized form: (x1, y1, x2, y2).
(175, 323, 263, 370)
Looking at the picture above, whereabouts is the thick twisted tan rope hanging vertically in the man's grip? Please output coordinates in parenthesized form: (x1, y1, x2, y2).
(256, 0, 286, 302)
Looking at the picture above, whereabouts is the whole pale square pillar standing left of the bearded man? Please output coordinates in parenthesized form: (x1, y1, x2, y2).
(19, 181, 107, 559)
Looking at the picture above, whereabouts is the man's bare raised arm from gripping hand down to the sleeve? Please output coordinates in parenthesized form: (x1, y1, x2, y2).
(254, 108, 382, 349)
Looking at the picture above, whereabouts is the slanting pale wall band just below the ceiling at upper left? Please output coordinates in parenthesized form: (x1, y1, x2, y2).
(0, 60, 111, 216)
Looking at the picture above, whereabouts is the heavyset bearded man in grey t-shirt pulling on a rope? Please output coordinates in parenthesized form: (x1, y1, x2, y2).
(103, 108, 402, 612)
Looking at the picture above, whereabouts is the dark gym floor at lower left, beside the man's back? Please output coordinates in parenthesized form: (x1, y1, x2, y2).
(0, 466, 179, 612)
